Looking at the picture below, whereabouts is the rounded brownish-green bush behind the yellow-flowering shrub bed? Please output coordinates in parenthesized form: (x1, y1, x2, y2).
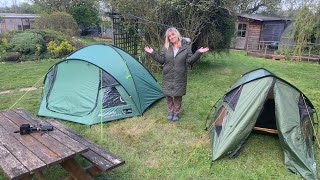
(35, 12, 79, 37)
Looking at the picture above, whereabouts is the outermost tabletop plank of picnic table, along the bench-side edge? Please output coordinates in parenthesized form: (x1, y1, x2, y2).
(13, 109, 88, 153)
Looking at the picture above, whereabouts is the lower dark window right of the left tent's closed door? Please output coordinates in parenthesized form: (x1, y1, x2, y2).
(102, 87, 127, 108)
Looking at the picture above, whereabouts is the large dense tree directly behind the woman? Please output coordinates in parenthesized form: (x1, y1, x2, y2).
(111, 0, 234, 50)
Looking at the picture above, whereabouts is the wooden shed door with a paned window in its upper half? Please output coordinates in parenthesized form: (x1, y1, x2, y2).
(234, 22, 249, 49)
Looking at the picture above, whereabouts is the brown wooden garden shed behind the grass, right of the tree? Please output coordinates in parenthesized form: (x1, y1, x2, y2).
(232, 14, 291, 51)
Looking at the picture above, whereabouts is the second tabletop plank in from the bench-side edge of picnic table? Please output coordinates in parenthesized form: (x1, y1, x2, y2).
(2, 110, 76, 163)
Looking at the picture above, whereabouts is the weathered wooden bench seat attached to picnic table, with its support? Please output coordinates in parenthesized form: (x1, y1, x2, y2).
(47, 120, 125, 177)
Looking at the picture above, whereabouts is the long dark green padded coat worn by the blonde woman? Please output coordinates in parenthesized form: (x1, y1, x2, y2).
(151, 39, 201, 97)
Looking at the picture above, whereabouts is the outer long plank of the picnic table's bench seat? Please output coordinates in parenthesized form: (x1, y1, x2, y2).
(48, 120, 123, 164)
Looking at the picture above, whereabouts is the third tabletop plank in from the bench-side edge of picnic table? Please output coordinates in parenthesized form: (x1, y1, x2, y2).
(0, 112, 59, 165)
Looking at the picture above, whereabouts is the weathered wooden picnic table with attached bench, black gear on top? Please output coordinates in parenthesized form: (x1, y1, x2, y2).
(0, 109, 124, 180)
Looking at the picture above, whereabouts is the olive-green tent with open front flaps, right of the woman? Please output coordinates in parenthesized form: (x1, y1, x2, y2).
(208, 69, 318, 179)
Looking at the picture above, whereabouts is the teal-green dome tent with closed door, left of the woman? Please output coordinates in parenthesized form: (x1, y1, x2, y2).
(38, 44, 164, 125)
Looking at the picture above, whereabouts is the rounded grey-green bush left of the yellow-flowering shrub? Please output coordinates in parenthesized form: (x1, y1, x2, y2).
(9, 31, 44, 54)
